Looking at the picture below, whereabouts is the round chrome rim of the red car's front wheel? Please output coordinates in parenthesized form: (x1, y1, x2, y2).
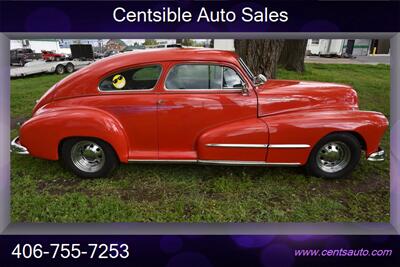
(317, 141, 351, 173)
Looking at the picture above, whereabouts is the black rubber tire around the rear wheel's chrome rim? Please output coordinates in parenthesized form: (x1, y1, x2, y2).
(60, 137, 119, 178)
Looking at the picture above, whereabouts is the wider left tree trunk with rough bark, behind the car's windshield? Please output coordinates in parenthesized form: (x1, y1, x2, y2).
(235, 39, 284, 78)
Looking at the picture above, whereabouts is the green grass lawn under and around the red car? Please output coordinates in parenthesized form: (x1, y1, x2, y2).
(11, 64, 390, 222)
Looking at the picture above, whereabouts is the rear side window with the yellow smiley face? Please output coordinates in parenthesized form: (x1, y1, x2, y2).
(99, 65, 161, 91)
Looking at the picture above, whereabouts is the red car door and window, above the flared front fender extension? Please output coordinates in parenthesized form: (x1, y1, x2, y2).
(157, 62, 266, 161)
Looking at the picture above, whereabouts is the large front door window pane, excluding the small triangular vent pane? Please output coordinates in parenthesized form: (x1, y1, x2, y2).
(165, 64, 222, 89)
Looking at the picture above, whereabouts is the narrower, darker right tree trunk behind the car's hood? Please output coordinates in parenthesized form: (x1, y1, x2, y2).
(278, 40, 307, 72)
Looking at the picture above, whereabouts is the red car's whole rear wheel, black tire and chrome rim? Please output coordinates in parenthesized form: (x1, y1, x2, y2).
(61, 138, 118, 178)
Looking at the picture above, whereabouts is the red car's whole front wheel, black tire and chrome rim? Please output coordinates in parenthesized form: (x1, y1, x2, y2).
(306, 133, 361, 179)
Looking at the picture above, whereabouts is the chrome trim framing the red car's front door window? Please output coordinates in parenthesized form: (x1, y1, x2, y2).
(163, 61, 247, 93)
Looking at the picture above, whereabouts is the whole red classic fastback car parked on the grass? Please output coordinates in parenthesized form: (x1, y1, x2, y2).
(12, 48, 388, 178)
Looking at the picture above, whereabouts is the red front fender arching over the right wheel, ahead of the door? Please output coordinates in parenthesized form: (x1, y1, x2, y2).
(262, 110, 388, 164)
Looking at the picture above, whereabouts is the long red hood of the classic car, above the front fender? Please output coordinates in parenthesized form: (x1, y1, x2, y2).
(256, 80, 358, 116)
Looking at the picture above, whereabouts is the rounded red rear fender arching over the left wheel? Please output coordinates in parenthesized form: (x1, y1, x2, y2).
(20, 107, 129, 162)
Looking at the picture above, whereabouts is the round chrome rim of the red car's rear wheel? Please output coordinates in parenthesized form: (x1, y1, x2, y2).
(71, 141, 105, 172)
